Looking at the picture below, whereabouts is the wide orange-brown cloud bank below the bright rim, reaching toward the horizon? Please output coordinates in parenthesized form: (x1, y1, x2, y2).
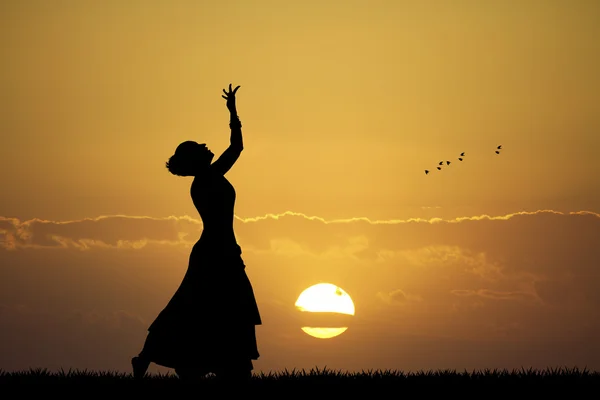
(0, 210, 600, 372)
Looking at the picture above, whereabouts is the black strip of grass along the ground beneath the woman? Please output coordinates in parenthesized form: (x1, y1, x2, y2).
(0, 368, 600, 392)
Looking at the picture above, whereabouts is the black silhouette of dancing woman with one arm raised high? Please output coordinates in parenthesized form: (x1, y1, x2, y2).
(131, 84, 262, 379)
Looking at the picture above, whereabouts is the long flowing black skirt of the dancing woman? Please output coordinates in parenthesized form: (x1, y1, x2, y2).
(143, 241, 262, 373)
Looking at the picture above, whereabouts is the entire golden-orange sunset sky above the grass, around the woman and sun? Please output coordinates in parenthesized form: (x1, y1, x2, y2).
(0, 0, 600, 372)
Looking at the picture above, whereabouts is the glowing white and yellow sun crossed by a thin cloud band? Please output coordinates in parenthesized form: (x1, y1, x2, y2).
(295, 283, 355, 339)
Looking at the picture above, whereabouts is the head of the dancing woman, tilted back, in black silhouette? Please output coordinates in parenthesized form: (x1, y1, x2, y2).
(166, 141, 215, 176)
